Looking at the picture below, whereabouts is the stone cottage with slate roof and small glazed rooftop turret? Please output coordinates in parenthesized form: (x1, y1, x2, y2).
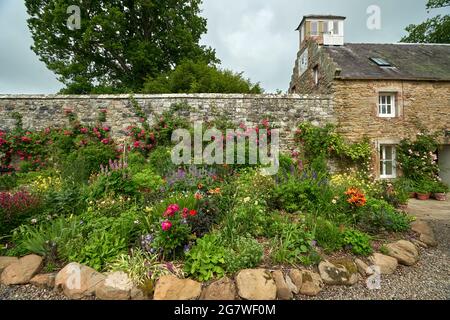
(289, 15, 450, 185)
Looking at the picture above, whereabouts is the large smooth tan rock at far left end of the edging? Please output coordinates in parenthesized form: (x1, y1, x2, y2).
(1, 254, 42, 285)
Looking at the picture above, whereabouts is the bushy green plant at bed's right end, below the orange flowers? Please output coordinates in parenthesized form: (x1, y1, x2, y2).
(358, 199, 411, 233)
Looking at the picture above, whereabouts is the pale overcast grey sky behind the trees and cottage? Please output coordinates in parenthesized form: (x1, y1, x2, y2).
(0, 0, 448, 93)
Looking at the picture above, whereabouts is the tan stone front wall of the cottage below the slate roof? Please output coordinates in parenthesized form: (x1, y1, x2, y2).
(333, 80, 450, 180)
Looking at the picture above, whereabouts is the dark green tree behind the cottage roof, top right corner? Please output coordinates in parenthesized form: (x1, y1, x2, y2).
(400, 0, 450, 43)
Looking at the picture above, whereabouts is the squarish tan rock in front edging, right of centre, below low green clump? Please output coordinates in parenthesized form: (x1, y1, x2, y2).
(236, 269, 277, 300)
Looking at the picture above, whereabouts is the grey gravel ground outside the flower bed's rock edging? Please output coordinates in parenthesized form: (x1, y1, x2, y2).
(0, 221, 450, 300)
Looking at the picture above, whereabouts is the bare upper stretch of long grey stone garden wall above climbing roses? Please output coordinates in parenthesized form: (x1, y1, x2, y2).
(0, 94, 335, 150)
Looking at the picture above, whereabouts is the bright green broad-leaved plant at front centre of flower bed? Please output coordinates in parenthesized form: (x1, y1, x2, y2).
(185, 234, 226, 281)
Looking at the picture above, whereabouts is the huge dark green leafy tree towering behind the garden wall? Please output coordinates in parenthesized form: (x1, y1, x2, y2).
(25, 0, 218, 93)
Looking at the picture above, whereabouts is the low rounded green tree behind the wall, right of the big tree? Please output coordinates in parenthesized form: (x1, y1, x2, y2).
(143, 60, 263, 94)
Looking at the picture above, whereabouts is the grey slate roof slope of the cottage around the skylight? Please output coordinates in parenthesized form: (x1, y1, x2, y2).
(323, 43, 450, 81)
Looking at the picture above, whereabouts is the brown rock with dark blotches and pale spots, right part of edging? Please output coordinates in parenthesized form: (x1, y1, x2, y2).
(319, 261, 358, 285)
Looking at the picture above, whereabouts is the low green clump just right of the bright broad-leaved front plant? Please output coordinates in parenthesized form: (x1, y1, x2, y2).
(225, 237, 263, 273)
